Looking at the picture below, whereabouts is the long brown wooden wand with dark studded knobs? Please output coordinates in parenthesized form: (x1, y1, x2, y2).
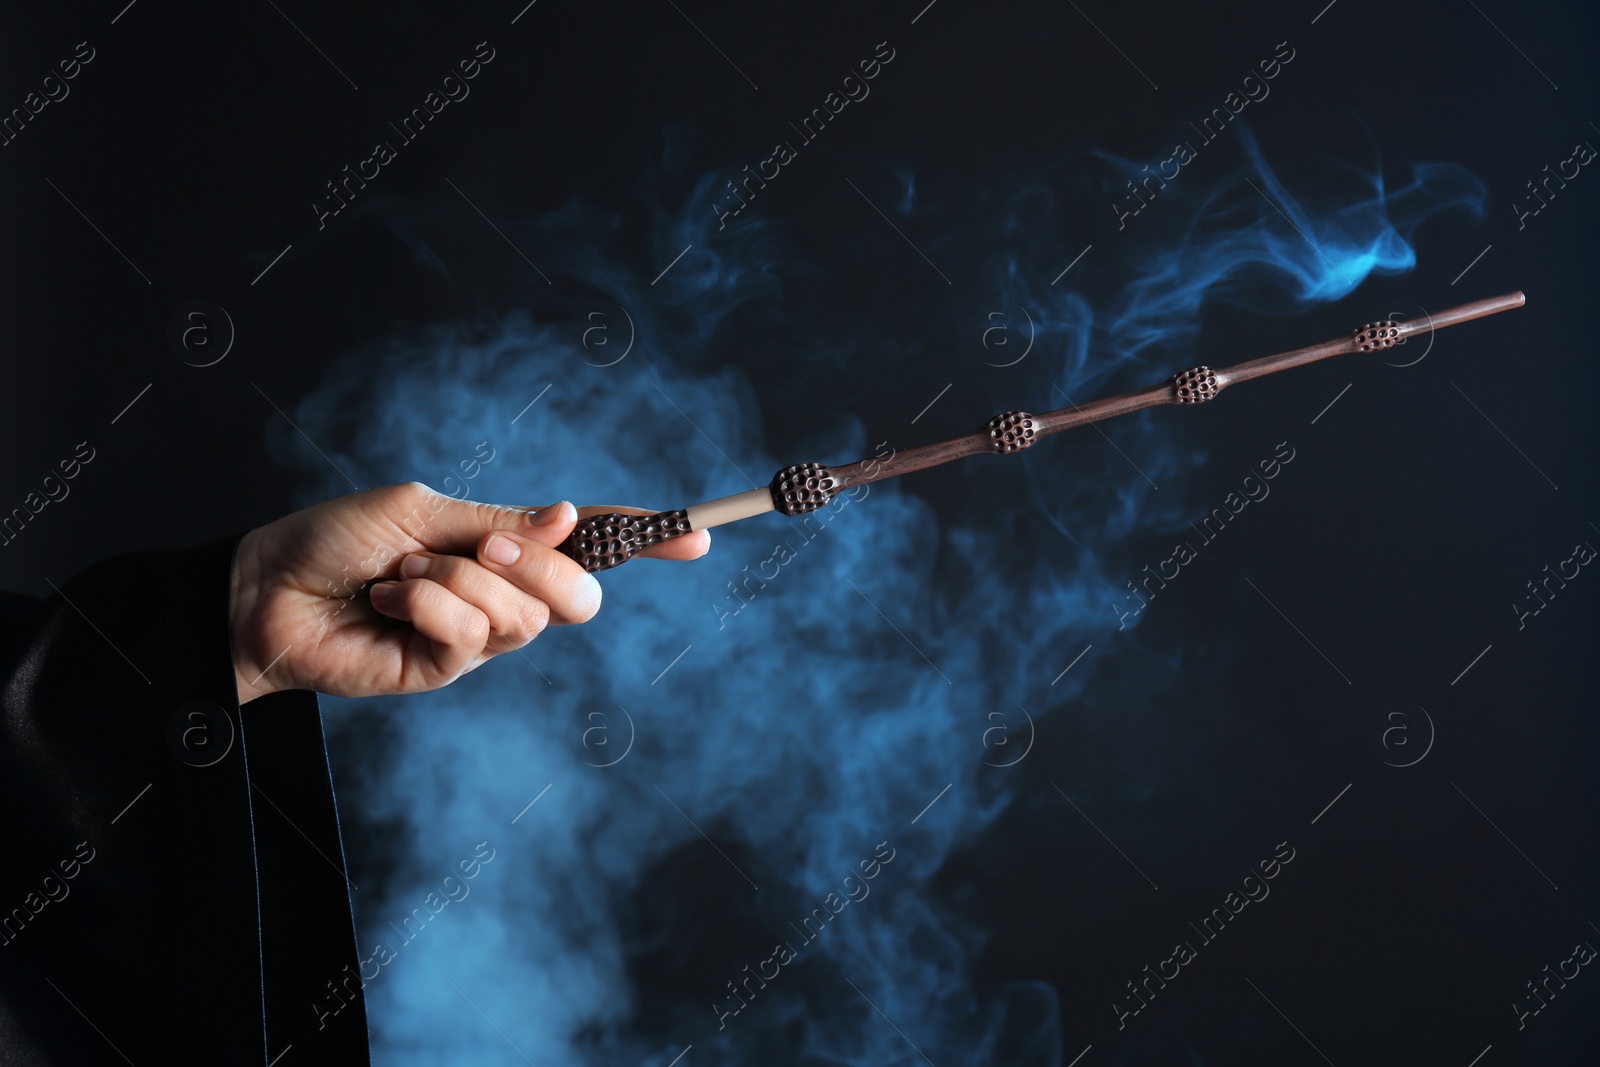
(560, 290, 1526, 571)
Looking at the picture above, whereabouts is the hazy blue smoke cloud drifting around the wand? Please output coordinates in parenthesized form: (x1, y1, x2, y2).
(270, 131, 1483, 1067)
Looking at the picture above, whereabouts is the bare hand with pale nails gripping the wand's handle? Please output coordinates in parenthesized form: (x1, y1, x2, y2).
(229, 482, 710, 704)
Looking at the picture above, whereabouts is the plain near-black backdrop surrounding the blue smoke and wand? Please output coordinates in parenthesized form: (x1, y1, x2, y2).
(0, 0, 1600, 1067)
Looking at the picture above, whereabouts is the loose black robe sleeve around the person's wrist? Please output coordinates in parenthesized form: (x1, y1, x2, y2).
(0, 536, 368, 1067)
